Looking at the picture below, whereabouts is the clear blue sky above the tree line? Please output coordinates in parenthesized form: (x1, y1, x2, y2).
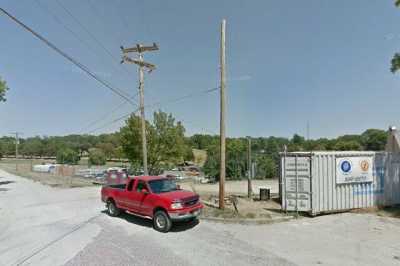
(0, 0, 400, 138)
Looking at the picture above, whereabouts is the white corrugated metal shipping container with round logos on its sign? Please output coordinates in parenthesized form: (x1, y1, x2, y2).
(280, 151, 400, 215)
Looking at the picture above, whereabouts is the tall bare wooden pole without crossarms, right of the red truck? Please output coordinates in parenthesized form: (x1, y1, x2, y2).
(219, 19, 226, 209)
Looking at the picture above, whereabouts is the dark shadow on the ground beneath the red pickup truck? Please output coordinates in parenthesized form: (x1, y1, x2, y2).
(101, 210, 200, 233)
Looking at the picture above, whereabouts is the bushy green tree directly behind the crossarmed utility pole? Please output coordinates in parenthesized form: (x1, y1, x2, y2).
(120, 111, 186, 174)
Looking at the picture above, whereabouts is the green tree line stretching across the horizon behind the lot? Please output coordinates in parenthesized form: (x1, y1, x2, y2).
(0, 108, 388, 179)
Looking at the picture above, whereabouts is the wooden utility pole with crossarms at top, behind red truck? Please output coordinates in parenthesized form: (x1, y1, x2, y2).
(121, 43, 158, 175)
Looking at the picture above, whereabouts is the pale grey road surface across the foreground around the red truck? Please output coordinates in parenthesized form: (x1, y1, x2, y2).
(0, 170, 400, 265)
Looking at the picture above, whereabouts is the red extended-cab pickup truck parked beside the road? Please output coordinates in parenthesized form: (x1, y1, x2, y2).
(101, 176, 204, 232)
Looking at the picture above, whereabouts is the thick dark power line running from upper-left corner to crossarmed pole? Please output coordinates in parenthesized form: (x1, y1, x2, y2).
(0, 7, 137, 105)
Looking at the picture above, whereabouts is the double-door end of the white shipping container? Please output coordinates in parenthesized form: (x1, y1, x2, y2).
(283, 156, 311, 211)
